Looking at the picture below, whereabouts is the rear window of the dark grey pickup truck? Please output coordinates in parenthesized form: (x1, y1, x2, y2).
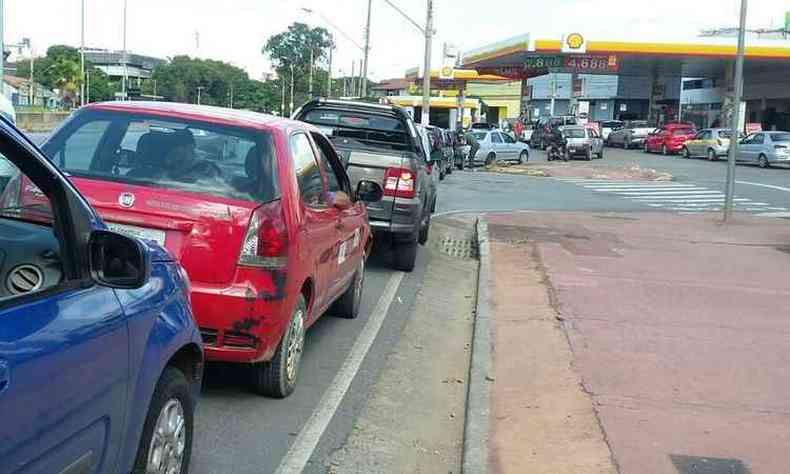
(300, 108, 412, 150)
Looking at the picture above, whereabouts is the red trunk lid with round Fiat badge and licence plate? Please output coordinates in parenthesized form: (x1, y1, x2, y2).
(72, 177, 258, 283)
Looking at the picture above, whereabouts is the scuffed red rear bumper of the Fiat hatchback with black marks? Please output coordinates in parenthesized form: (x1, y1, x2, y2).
(191, 268, 290, 363)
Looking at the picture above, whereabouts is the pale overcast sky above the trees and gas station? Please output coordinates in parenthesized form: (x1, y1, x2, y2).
(4, 0, 790, 80)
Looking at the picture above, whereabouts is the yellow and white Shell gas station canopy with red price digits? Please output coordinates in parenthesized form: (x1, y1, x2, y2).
(460, 33, 790, 79)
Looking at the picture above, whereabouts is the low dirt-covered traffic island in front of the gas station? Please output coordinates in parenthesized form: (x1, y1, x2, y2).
(483, 161, 673, 181)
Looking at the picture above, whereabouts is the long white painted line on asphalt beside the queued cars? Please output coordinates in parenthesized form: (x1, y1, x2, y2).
(275, 272, 406, 474)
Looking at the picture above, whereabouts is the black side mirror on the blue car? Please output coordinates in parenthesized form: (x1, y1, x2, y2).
(88, 230, 151, 290)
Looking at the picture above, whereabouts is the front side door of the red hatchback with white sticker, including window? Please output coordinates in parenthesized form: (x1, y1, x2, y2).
(312, 133, 368, 300)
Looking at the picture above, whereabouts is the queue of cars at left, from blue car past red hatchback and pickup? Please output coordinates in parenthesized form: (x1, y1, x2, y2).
(0, 99, 463, 473)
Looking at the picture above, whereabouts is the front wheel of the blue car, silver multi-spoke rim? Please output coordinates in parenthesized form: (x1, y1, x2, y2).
(132, 367, 195, 474)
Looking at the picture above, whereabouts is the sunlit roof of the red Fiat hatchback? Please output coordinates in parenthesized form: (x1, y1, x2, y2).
(81, 101, 318, 131)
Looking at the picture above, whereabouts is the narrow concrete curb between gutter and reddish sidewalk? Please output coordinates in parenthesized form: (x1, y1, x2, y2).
(461, 217, 494, 474)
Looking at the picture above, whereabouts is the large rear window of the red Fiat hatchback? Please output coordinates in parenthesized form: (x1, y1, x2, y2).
(43, 111, 278, 201)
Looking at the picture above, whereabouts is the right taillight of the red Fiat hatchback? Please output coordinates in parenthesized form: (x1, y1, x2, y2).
(239, 201, 288, 268)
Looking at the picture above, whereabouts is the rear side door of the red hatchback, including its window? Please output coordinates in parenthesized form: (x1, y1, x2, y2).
(290, 132, 340, 319)
